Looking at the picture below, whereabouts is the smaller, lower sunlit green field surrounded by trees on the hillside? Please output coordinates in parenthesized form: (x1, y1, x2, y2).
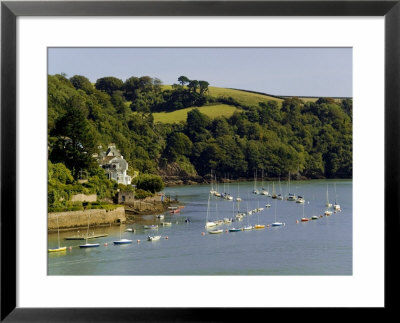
(153, 104, 241, 123)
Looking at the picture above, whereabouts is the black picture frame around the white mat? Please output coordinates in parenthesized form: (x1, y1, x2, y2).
(0, 0, 400, 322)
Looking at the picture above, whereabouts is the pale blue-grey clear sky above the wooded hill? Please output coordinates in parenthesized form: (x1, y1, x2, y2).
(48, 47, 352, 97)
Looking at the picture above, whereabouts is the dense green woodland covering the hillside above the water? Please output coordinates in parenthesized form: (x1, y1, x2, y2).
(48, 75, 352, 210)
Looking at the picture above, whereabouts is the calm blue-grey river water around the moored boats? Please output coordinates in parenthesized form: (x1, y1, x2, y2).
(48, 180, 352, 275)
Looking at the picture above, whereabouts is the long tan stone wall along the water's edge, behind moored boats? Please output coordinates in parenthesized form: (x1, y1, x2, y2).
(47, 207, 126, 231)
